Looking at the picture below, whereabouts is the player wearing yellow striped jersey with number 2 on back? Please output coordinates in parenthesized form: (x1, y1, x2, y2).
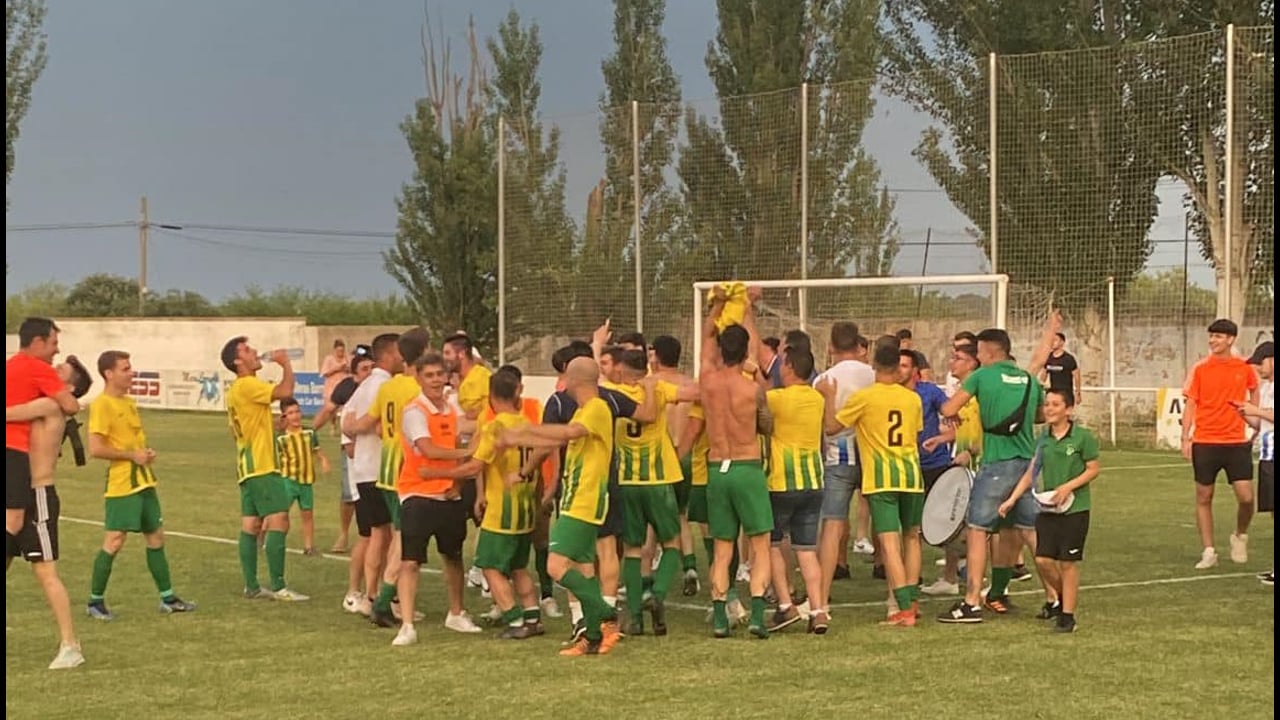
(818, 337, 924, 626)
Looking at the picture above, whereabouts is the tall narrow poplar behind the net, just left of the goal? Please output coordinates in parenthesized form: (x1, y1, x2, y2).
(576, 0, 684, 327)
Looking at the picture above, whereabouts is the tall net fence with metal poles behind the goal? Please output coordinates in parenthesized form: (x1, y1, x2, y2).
(499, 27, 1275, 445)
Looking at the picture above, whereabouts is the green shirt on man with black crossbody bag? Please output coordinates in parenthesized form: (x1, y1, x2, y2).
(960, 360, 1044, 465)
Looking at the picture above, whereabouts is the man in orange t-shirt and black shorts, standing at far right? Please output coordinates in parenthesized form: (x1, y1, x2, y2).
(1183, 319, 1258, 570)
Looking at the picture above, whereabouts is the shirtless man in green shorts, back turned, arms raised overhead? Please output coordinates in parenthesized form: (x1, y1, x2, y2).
(699, 283, 773, 639)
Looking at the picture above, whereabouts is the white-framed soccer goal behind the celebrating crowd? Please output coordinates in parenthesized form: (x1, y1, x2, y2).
(692, 274, 1009, 376)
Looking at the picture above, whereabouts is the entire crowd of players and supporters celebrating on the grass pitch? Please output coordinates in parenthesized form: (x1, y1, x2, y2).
(6, 283, 1274, 669)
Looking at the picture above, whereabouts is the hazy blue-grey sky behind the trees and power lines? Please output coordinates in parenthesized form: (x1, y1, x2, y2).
(6, 0, 1196, 300)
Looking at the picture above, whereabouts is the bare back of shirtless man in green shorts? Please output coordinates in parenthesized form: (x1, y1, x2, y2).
(699, 368, 760, 462)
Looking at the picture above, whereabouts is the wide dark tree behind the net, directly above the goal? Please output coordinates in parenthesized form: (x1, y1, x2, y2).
(678, 0, 897, 301)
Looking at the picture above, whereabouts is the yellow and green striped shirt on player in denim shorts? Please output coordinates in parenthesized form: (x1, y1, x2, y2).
(765, 384, 826, 492)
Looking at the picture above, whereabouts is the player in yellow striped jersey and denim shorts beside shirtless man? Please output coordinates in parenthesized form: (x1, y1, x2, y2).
(765, 347, 827, 632)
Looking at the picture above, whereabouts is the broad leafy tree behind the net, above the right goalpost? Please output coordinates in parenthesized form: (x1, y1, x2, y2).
(887, 0, 1161, 392)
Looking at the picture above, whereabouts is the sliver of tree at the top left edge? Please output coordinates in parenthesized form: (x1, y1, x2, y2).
(4, 0, 46, 210)
